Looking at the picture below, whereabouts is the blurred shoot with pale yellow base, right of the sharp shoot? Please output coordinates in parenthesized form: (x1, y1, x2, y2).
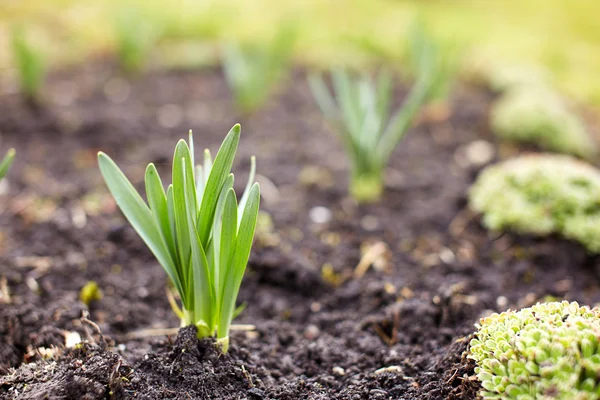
(309, 66, 437, 202)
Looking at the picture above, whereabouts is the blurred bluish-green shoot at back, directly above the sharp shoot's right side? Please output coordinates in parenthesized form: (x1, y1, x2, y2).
(222, 24, 296, 114)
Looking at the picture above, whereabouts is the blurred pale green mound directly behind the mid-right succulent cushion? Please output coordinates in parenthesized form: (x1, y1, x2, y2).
(490, 86, 597, 157)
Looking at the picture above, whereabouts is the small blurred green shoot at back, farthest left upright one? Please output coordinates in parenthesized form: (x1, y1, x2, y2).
(12, 25, 46, 104)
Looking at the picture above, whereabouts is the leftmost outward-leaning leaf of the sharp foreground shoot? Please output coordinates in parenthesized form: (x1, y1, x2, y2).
(98, 152, 184, 295)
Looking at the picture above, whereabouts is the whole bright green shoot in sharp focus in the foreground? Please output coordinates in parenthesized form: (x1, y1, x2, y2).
(98, 125, 260, 352)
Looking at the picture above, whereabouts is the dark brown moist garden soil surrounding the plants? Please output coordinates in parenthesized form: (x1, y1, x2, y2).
(0, 63, 600, 400)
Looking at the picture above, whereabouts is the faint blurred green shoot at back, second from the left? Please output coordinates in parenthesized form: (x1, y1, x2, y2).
(115, 6, 160, 75)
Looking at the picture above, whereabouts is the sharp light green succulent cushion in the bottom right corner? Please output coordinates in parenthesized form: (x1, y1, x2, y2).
(469, 301, 600, 400)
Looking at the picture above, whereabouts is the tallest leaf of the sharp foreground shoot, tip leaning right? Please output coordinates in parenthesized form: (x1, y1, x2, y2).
(198, 124, 240, 245)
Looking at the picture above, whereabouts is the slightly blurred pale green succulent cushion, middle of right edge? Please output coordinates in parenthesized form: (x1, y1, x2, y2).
(469, 154, 600, 253)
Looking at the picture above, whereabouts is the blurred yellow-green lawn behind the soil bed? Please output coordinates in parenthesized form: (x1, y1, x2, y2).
(0, 0, 600, 106)
